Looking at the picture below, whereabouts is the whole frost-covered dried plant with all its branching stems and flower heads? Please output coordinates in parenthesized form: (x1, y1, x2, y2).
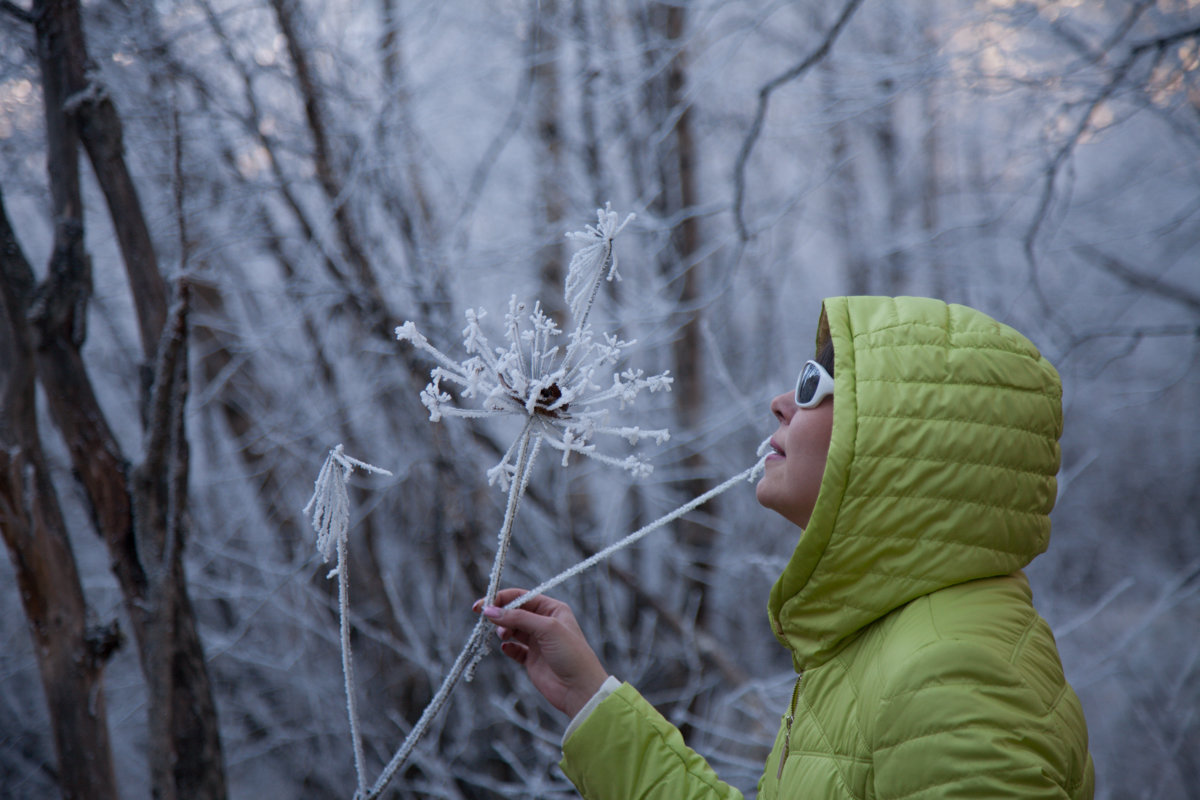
(306, 207, 763, 800)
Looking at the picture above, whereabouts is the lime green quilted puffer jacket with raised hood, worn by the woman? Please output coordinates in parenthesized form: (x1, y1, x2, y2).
(562, 297, 1093, 800)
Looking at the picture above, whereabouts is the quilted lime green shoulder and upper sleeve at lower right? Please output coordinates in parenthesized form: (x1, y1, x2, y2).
(871, 640, 1091, 800)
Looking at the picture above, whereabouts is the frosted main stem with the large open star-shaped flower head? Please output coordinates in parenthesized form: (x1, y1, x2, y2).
(362, 207, 676, 800)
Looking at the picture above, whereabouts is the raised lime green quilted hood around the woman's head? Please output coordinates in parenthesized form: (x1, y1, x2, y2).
(768, 297, 1062, 669)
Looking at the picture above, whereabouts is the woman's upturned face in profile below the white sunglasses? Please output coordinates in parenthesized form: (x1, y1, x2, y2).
(755, 392, 833, 528)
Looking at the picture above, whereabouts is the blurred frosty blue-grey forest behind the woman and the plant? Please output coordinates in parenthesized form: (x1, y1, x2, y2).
(0, 0, 1200, 800)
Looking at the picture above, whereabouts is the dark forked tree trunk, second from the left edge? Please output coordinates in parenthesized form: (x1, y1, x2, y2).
(25, 0, 226, 800)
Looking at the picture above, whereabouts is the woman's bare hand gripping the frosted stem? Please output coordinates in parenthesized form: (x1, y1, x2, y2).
(474, 589, 608, 717)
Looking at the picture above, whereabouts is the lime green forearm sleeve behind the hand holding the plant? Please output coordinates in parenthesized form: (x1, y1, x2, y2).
(560, 684, 742, 800)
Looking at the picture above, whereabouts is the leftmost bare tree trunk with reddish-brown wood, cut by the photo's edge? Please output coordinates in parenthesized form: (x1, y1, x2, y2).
(0, 183, 120, 800)
